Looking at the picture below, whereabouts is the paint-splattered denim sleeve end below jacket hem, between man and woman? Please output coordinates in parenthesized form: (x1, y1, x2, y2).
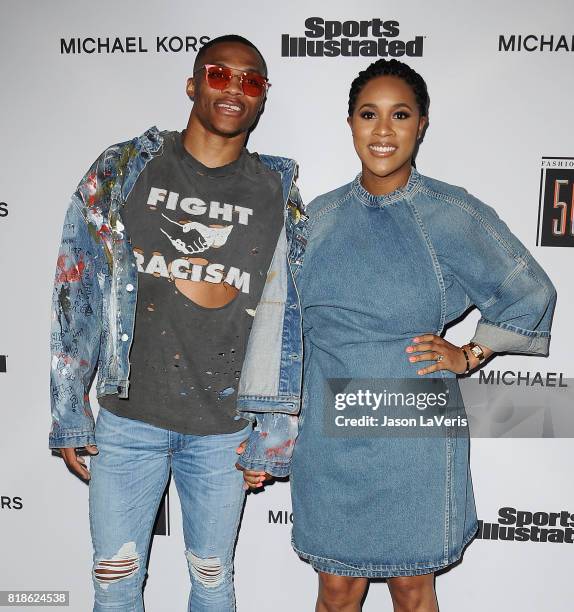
(238, 412, 298, 477)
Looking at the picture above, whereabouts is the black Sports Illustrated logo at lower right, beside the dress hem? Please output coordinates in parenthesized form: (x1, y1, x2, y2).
(476, 507, 574, 544)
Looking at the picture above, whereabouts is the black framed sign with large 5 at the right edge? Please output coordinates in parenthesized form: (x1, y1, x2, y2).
(536, 157, 574, 247)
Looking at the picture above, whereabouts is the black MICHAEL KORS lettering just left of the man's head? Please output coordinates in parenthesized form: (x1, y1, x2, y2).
(60, 35, 210, 55)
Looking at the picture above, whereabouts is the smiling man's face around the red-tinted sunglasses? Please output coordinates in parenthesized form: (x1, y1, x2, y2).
(187, 43, 265, 137)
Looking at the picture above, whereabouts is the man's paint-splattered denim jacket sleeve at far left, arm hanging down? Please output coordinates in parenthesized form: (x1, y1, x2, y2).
(49, 180, 107, 448)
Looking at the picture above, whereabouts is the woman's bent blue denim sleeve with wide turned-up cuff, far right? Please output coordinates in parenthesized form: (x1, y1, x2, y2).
(440, 196, 556, 355)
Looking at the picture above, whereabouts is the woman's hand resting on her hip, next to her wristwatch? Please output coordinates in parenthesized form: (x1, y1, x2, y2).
(406, 334, 470, 376)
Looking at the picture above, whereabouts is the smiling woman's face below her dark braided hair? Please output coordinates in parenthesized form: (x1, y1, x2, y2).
(347, 76, 427, 195)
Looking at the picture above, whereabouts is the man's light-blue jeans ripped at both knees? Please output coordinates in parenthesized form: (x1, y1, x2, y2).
(90, 408, 251, 612)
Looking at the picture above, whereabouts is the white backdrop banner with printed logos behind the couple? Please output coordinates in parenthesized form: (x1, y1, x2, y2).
(0, 0, 574, 612)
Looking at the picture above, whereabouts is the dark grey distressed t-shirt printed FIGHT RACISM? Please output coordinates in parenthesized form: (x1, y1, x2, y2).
(99, 132, 283, 435)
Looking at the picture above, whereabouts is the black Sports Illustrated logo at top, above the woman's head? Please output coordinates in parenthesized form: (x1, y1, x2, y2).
(281, 17, 424, 57)
